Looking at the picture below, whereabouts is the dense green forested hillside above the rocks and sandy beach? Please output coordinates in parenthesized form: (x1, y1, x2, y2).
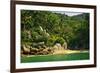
(21, 10, 89, 54)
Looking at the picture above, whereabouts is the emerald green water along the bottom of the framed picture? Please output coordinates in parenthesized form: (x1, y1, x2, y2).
(21, 52, 89, 63)
